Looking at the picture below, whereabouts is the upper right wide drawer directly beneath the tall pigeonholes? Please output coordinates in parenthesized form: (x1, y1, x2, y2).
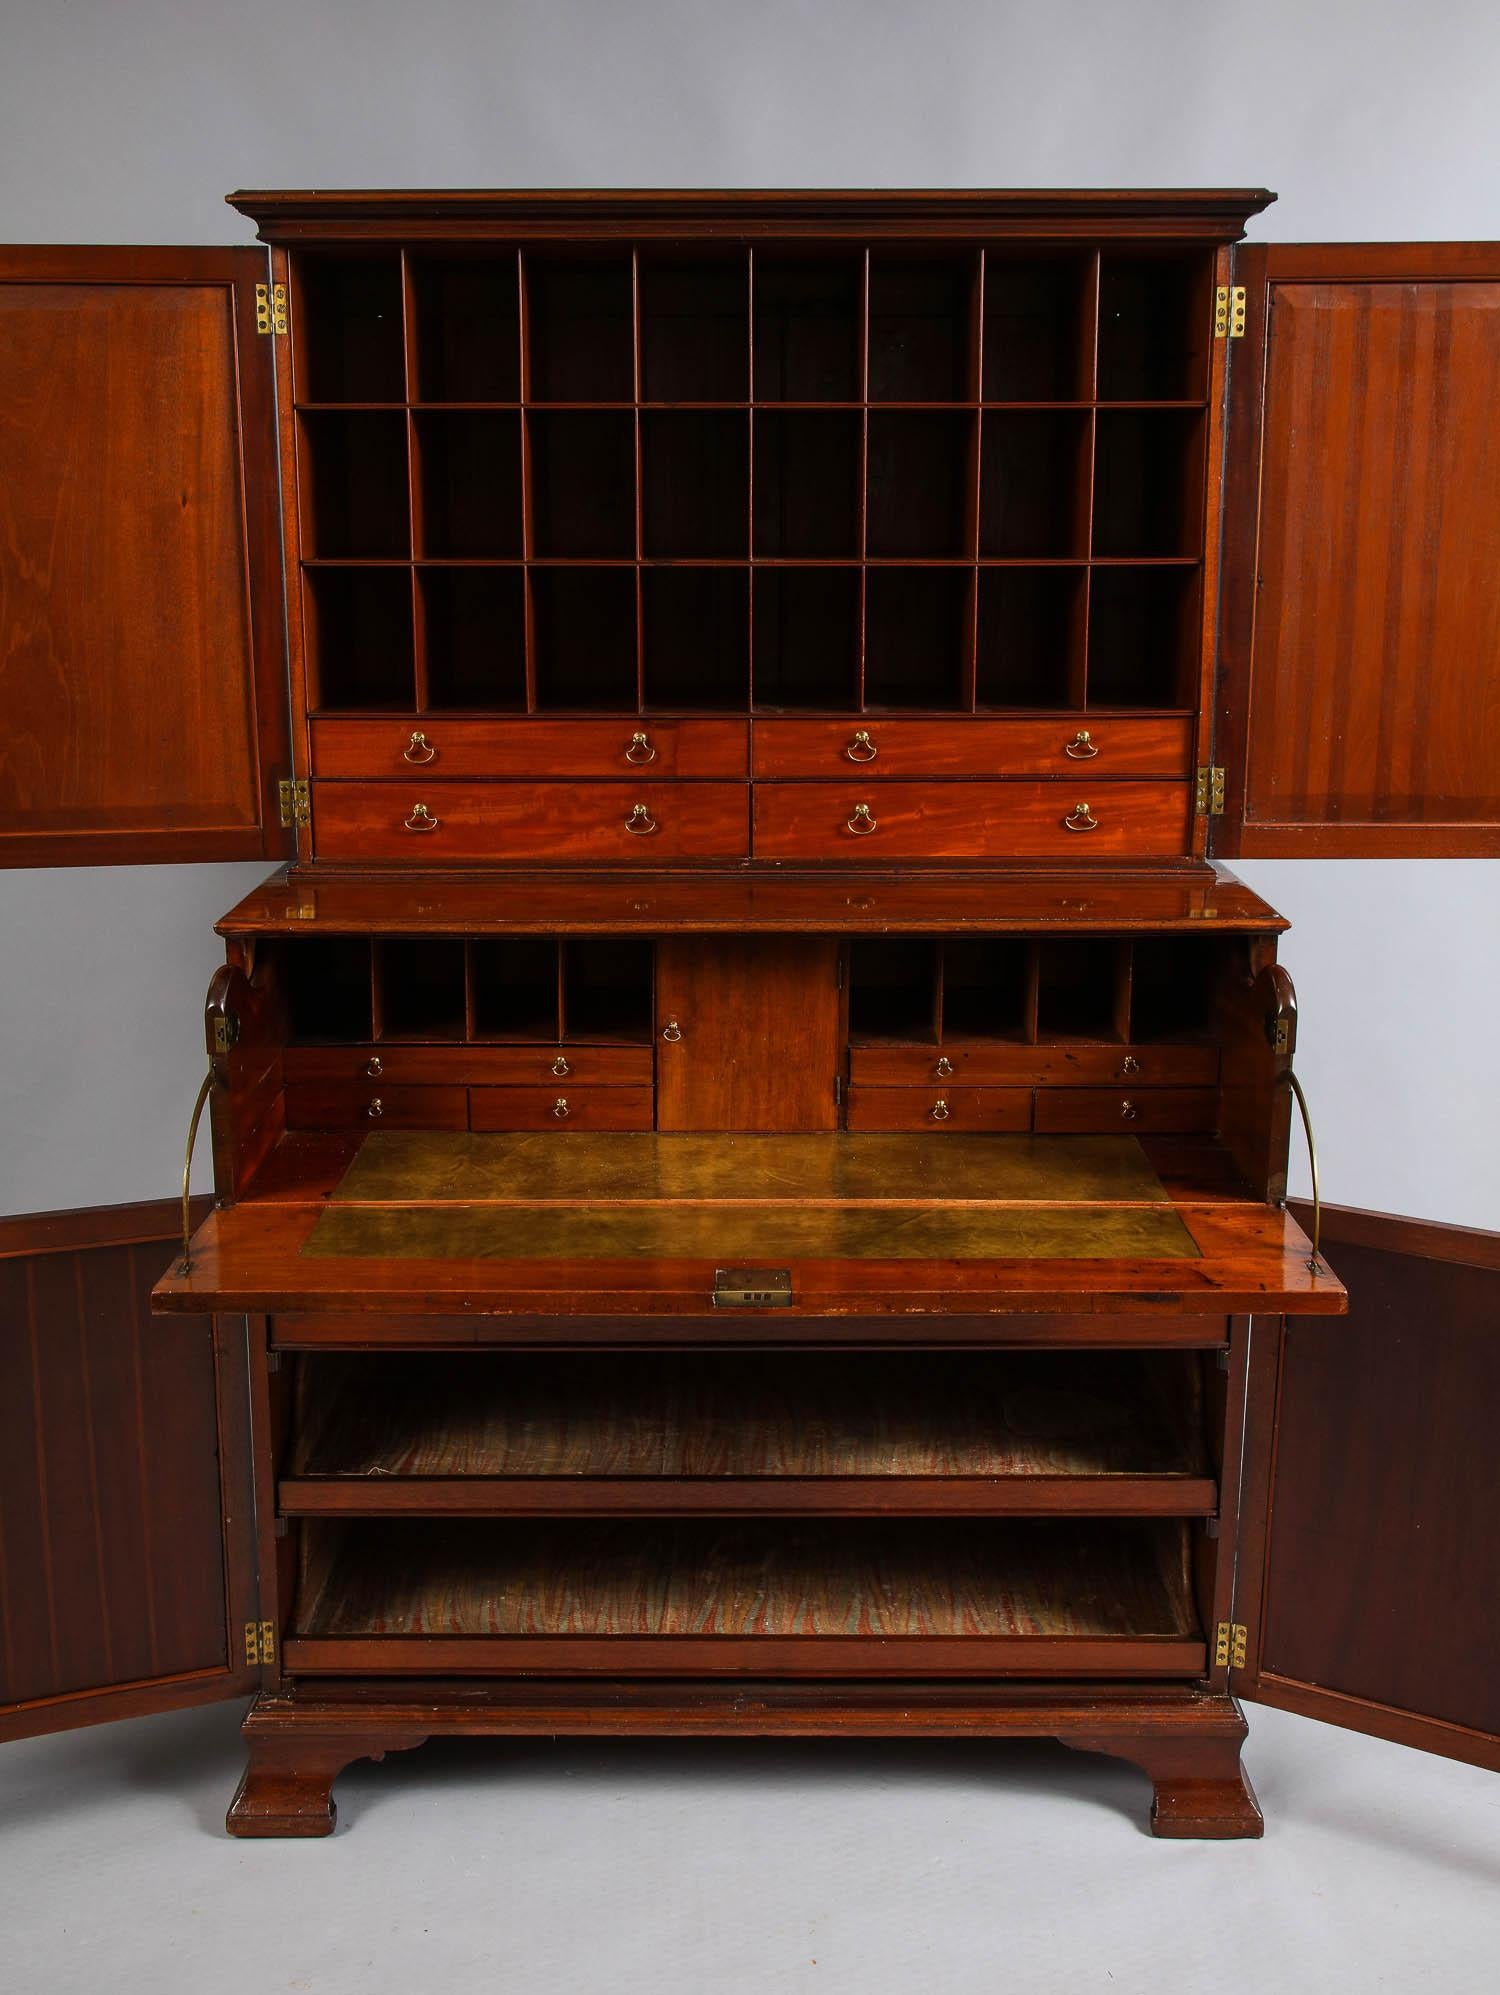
(750, 714, 1193, 780)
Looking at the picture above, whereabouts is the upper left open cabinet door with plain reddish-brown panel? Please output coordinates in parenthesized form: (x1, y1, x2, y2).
(0, 247, 291, 866)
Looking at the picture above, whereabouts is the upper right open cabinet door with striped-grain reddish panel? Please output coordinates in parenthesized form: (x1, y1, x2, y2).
(1213, 243, 1500, 858)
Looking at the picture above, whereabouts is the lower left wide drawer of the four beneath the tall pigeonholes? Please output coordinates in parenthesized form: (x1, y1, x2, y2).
(313, 778, 746, 866)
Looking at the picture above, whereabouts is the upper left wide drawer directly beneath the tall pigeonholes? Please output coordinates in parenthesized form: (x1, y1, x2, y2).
(311, 714, 748, 782)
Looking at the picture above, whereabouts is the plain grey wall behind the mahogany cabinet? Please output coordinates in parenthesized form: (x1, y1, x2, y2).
(0, 0, 1500, 1225)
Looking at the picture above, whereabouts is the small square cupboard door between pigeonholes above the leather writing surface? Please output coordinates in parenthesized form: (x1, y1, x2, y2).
(656, 936, 842, 1131)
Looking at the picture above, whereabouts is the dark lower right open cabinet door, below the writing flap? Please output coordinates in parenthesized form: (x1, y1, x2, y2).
(1231, 1209, 1500, 1772)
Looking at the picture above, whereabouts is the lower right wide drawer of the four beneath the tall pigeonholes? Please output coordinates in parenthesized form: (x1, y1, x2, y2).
(754, 782, 1193, 864)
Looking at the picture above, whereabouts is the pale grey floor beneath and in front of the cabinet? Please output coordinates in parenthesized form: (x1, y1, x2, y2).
(0, 1708, 1500, 1995)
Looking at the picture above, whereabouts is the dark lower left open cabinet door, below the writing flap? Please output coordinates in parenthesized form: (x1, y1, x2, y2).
(0, 1199, 261, 1740)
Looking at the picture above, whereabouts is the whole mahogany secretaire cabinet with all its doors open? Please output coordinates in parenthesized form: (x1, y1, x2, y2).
(0, 192, 1500, 1835)
